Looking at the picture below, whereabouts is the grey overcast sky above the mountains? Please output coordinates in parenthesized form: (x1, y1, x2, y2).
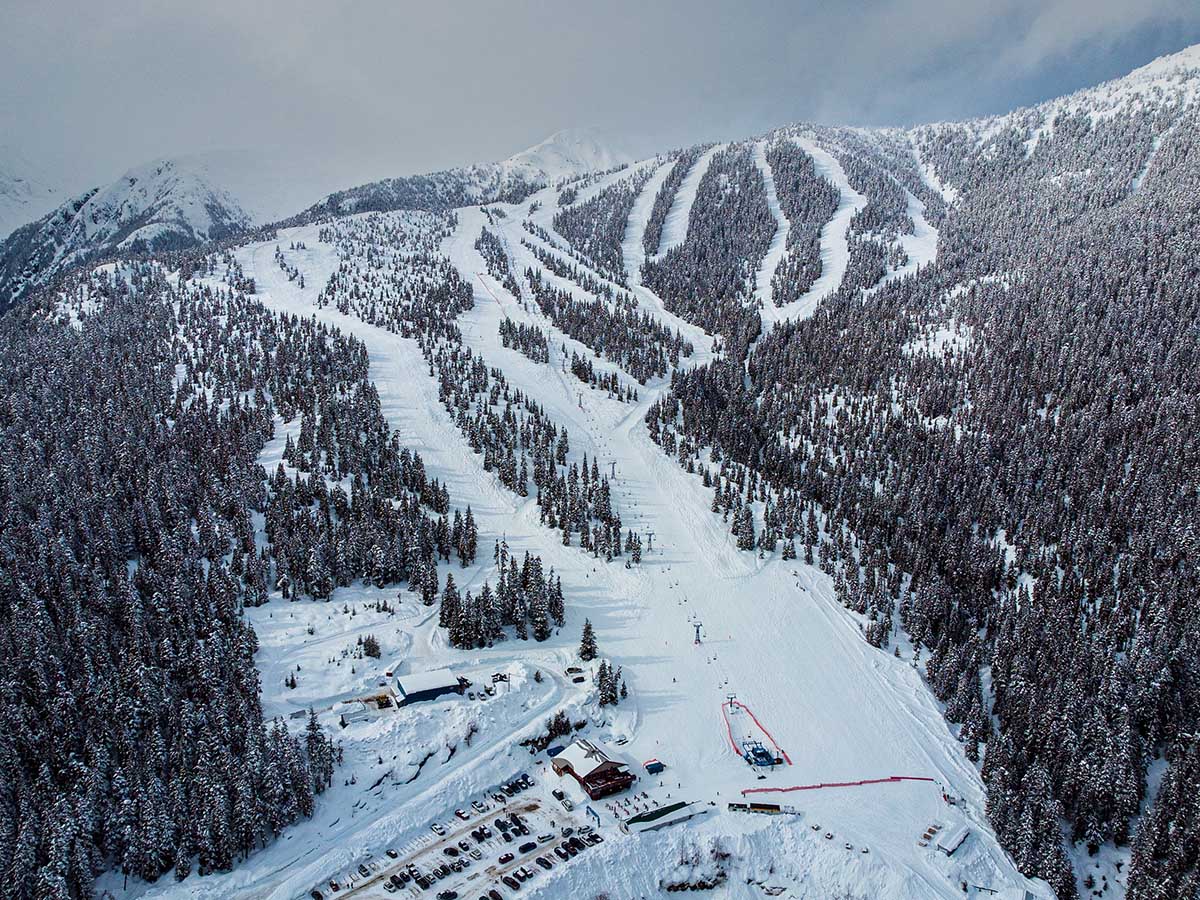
(0, 0, 1200, 194)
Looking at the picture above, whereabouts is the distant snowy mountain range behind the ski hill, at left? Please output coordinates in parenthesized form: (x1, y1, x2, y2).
(0, 130, 630, 310)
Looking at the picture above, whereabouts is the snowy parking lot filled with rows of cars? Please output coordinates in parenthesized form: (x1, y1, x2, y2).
(311, 776, 604, 900)
